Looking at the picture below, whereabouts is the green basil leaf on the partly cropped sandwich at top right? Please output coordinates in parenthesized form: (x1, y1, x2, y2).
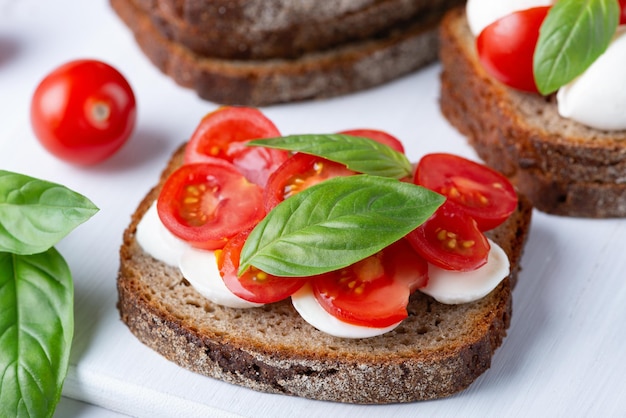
(533, 0, 620, 95)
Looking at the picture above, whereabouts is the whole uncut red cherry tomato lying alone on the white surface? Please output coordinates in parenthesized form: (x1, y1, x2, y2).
(30, 60, 137, 165)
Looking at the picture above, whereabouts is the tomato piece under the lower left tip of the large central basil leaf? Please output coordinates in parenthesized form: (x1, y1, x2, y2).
(216, 230, 308, 303)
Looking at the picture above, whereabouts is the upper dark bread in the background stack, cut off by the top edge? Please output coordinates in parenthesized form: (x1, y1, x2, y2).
(136, 0, 463, 59)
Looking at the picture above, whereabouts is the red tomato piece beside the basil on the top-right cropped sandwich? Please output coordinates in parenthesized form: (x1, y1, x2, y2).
(476, 6, 550, 93)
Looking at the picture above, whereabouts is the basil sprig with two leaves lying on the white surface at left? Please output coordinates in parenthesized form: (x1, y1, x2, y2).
(0, 170, 98, 417)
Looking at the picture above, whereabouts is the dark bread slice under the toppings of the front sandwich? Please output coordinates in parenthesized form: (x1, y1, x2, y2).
(117, 148, 532, 404)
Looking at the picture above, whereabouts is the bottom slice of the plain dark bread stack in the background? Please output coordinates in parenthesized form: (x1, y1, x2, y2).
(111, 0, 438, 106)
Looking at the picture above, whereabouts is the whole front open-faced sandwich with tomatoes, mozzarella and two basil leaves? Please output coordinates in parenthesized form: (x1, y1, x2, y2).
(118, 107, 532, 404)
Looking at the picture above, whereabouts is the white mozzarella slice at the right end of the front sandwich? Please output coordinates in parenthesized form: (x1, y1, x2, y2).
(419, 240, 510, 304)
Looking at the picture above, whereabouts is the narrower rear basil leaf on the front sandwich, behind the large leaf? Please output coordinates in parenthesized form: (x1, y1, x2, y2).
(248, 134, 413, 179)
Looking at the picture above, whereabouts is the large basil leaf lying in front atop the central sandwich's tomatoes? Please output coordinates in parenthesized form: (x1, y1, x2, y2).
(239, 175, 445, 277)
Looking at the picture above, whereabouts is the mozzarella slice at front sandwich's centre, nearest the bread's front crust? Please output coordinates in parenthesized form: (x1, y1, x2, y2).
(291, 283, 402, 338)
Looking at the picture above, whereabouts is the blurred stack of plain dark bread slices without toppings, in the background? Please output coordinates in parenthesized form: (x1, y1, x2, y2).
(110, 0, 461, 106)
